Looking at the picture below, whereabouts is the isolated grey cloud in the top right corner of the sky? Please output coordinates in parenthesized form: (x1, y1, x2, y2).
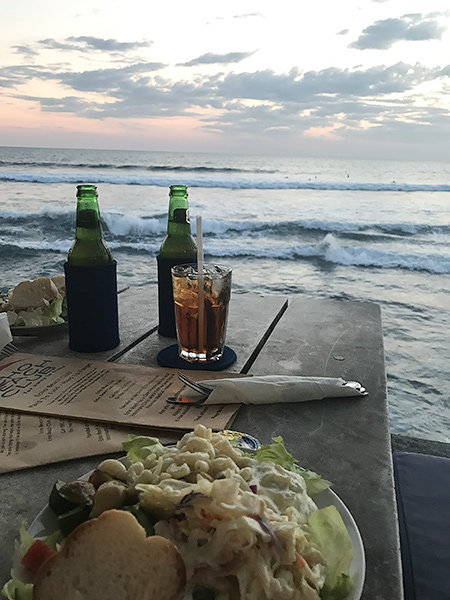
(349, 13, 446, 50)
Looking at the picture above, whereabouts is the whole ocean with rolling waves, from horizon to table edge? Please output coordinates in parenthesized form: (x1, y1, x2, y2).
(0, 147, 450, 442)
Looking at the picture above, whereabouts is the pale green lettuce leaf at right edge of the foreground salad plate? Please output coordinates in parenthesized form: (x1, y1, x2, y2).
(308, 506, 353, 600)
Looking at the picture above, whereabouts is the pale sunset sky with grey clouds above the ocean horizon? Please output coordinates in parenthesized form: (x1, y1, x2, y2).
(0, 0, 450, 161)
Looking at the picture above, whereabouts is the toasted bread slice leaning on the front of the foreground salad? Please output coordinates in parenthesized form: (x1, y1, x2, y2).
(33, 510, 186, 600)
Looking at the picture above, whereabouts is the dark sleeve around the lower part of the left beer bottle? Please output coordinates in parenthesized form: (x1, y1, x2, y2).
(64, 261, 120, 352)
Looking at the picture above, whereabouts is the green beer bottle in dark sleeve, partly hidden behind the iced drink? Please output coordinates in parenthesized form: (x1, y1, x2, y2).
(156, 185, 197, 337)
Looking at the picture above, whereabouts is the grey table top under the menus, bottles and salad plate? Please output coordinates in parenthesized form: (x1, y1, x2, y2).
(0, 286, 403, 600)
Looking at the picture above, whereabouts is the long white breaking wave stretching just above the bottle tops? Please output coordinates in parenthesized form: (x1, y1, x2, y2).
(0, 167, 450, 192)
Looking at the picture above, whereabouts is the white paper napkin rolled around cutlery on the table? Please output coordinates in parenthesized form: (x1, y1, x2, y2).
(183, 375, 367, 406)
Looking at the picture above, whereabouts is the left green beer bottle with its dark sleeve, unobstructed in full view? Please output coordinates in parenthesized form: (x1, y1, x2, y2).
(64, 185, 120, 352)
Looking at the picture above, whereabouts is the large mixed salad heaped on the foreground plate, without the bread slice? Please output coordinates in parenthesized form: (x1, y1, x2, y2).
(3, 425, 362, 600)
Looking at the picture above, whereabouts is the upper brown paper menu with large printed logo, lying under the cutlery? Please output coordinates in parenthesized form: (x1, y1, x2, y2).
(0, 353, 239, 430)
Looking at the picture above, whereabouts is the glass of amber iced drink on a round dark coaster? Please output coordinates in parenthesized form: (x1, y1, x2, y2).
(172, 264, 231, 362)
